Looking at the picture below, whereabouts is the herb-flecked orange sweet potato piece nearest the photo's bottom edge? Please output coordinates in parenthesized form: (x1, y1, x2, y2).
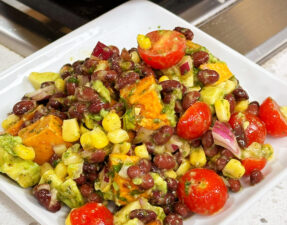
(114, 174, 148, 205)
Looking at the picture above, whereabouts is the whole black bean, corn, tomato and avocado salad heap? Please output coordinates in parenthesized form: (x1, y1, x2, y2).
(0, 27, 287, 225)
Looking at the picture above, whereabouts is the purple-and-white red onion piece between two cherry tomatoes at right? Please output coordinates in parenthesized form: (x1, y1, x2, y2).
(212, 121, 241, 158)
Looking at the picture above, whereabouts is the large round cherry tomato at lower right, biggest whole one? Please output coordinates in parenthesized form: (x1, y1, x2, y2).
(177, 168, 228, 215)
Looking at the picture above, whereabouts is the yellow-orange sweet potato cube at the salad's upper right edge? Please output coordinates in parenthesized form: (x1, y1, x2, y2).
(199, 62, 233, 86)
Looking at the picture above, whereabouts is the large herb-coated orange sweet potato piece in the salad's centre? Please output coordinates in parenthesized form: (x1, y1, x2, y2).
(120, 76, 170, 130)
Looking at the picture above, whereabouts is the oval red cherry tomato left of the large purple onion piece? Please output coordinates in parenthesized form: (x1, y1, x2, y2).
(177, 102, 211, 140)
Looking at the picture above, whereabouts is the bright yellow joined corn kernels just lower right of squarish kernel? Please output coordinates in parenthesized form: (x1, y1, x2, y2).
(80, 127, 109, 149)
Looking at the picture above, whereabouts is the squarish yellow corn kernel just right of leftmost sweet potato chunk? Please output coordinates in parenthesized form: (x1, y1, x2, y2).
(62, 118, 80, 142)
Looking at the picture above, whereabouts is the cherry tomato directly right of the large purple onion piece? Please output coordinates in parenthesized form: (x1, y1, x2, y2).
(229, 113, 267, 147)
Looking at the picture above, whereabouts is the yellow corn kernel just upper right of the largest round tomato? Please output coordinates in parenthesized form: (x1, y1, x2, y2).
(222, 159, 245, 179)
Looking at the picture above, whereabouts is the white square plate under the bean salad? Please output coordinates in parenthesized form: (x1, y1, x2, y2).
(0, 0, 287, 225)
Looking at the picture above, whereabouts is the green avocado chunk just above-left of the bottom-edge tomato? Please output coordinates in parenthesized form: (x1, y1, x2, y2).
(58, 179, 84, 208)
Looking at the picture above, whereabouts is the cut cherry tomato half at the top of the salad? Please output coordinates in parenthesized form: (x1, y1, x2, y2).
(138, 30, 186, 69)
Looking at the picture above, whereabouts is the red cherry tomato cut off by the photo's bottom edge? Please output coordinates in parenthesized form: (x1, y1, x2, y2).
(70, 203, 113, 225)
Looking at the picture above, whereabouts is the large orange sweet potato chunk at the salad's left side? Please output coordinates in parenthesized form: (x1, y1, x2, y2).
(18, 115, 65, 165)
